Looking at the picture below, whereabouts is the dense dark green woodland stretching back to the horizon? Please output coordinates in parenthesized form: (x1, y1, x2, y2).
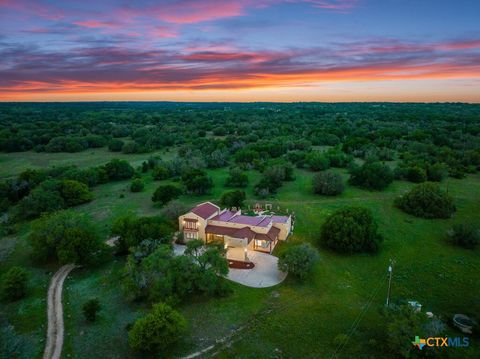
(0, 102, 480, 203)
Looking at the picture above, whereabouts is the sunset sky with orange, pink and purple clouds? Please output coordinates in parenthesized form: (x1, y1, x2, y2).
(0, 0, 480, 102)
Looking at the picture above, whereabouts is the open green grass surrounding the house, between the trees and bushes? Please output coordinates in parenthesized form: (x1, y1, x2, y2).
(0, 149, 480, 358)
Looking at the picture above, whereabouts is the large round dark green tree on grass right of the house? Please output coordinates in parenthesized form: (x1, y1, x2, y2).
(320, 207, 383, 253)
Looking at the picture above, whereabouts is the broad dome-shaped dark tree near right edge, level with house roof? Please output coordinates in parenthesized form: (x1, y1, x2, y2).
(395, 182, 456, 218)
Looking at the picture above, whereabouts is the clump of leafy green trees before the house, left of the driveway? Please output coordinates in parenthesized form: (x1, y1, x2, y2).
(123, 240, 229, 301)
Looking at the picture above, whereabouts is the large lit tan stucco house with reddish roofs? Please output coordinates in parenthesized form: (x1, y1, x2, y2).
(178, 202, 292, 253)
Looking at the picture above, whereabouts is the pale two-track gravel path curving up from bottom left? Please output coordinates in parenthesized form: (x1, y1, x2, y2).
(43, 264, 75, 359)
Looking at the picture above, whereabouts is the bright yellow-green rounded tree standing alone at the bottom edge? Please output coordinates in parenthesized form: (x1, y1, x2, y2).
(128, 303, 187, 351)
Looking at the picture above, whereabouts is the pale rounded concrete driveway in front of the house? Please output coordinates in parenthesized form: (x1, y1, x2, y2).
(227, 251, 287, 288)
